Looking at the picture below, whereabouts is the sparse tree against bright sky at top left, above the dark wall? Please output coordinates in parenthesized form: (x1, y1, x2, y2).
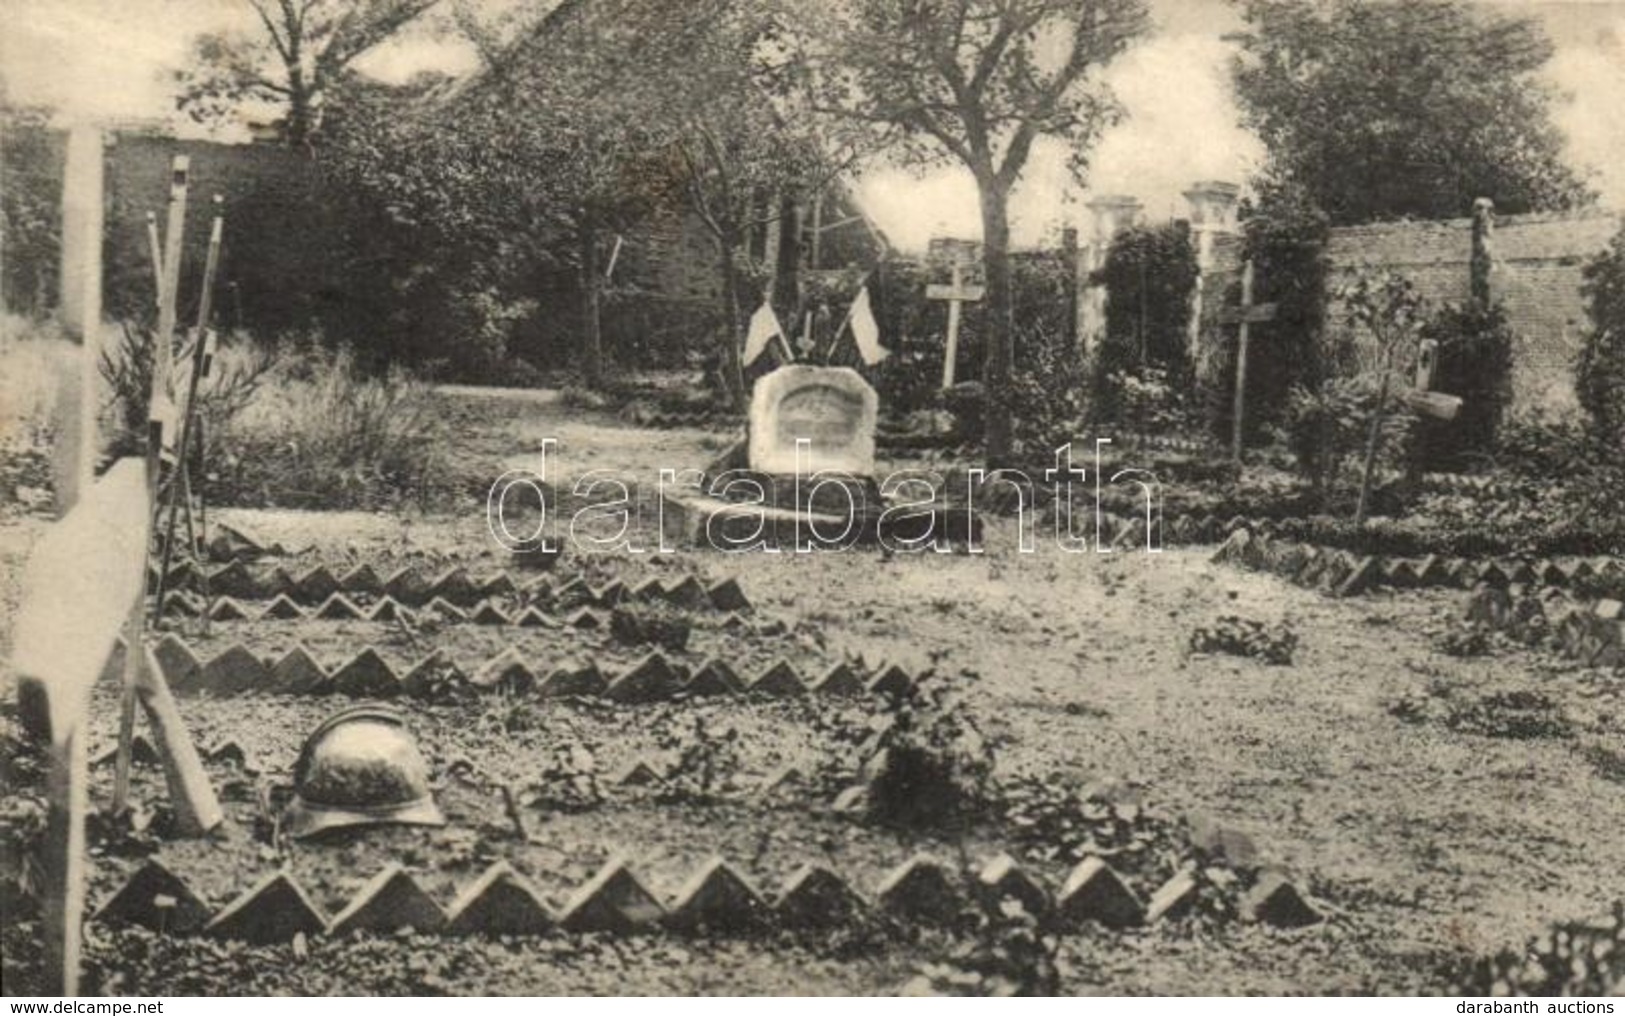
(176, 0, 440, 146)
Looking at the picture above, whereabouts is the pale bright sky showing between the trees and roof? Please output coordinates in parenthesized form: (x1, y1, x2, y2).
(0, 0, 1625, 250)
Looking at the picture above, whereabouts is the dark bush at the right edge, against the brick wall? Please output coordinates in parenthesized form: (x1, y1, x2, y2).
(1575, 229, 1625, 462)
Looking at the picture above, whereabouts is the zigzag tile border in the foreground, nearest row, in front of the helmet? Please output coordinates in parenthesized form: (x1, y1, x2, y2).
(96, 853, 1323, 943)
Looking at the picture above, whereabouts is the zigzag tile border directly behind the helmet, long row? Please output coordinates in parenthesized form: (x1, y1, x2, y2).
(143, 632, 917, 702)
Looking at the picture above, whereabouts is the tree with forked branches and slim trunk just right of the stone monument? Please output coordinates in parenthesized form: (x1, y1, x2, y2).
(798, 0, 1147, 463)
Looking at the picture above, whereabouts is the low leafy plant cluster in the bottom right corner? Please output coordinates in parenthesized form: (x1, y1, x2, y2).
(1450, 901, 1625, 998)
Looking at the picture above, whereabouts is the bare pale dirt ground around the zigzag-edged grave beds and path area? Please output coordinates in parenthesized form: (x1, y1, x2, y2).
(0, 386, 1625, 993)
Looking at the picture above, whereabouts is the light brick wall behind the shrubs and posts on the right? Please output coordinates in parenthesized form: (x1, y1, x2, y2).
(1203, 211, 1622, 416)
